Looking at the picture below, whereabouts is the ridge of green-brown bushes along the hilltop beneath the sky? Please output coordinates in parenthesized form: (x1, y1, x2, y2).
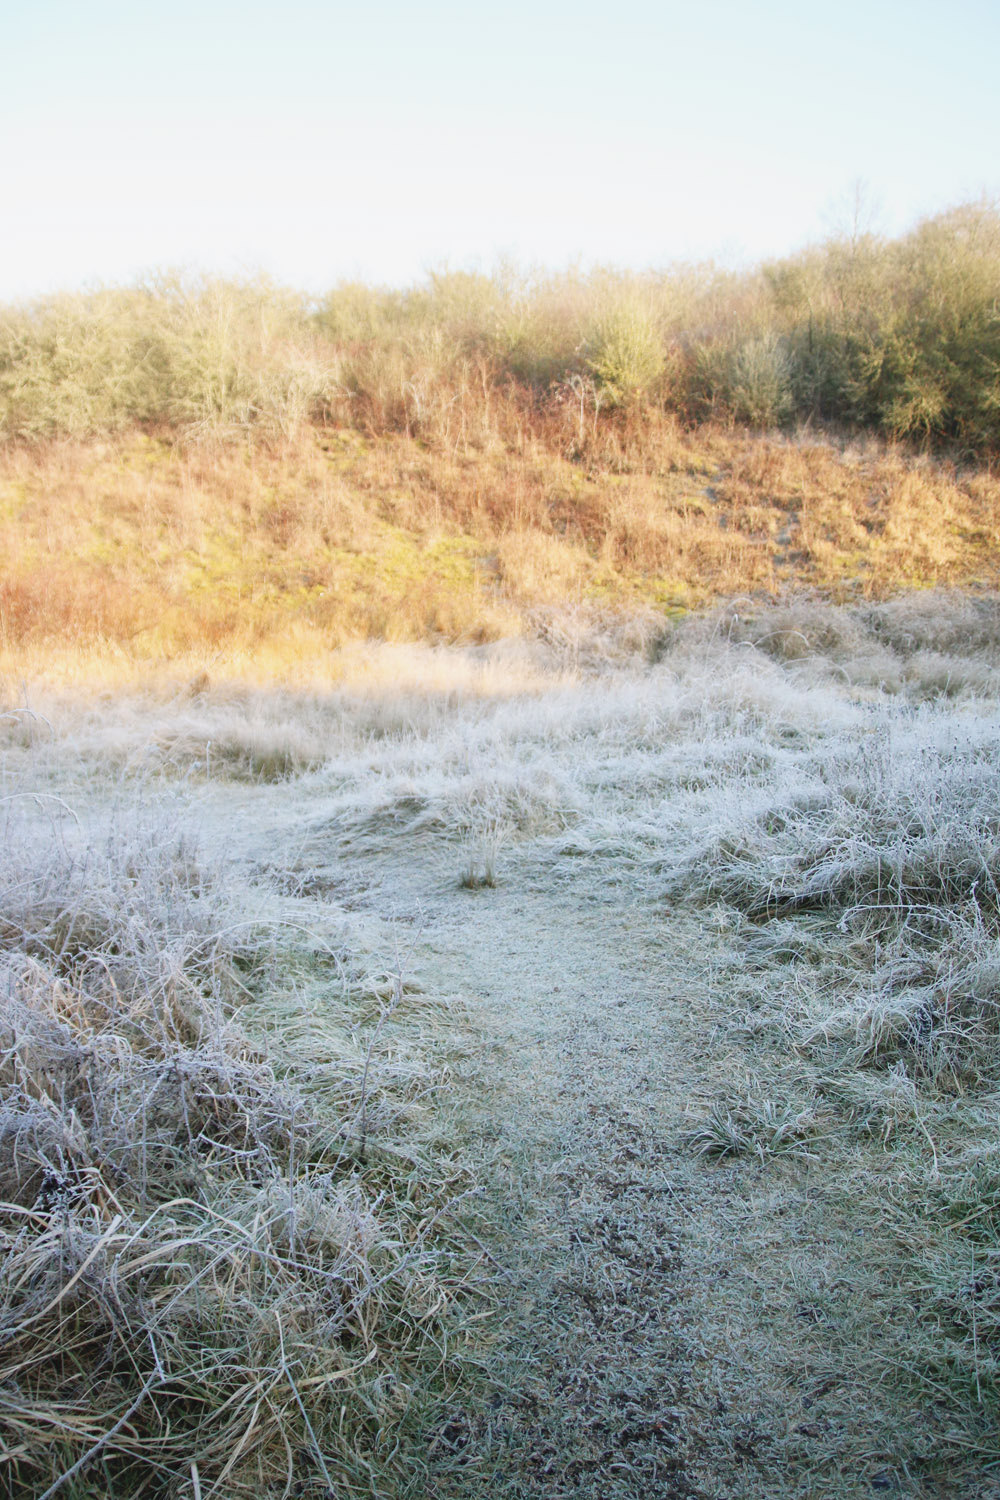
(0, 200, 1000, 459)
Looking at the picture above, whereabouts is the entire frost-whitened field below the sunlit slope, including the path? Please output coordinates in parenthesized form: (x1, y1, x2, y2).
(0, 591, 1000, 1500)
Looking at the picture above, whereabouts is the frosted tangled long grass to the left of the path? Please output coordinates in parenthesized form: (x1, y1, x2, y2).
(0, 786, 468, 1500)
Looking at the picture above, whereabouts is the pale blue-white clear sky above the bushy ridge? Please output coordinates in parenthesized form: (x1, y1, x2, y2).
(0, 0, 1000, 300)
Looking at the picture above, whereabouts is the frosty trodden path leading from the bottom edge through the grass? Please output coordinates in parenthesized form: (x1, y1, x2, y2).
(197, 794, 953, 1500)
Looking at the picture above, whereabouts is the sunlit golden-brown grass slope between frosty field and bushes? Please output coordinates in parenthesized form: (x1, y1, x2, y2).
(0, 420, 1000, 684)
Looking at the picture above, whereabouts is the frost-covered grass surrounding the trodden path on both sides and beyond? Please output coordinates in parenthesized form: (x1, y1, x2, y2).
(0, 594, 1000, 1494)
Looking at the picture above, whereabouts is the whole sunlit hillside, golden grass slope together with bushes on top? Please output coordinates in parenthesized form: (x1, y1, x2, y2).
(0, 203, 1000, 678)
